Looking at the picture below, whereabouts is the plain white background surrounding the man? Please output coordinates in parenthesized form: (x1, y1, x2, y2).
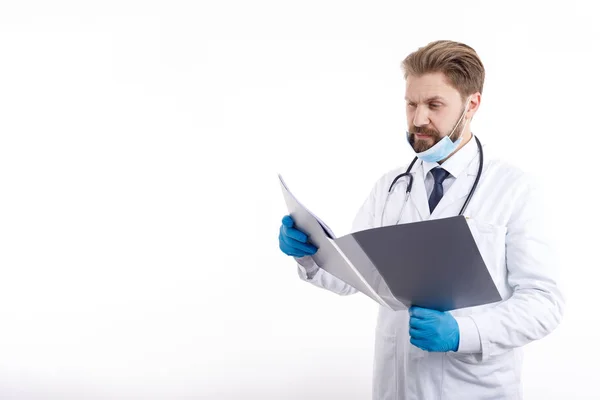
(0, 0, 600, 399)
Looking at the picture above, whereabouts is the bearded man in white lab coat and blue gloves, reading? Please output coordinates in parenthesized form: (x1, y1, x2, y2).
(279, 41, 564, 400)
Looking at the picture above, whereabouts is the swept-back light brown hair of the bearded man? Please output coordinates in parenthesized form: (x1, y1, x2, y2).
(402, 40, 485, 101)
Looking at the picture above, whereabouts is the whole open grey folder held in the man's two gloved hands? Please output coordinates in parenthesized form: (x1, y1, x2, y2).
(279, 176, 502, 311)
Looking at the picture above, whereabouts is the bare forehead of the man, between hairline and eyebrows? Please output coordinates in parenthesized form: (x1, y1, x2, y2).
(405, 72, 460, 102)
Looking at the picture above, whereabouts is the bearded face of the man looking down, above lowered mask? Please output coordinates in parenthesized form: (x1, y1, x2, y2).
(405, 72, 479, 153)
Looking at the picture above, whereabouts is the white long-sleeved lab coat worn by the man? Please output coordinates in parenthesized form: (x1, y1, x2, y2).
(296, 139, 564, 400)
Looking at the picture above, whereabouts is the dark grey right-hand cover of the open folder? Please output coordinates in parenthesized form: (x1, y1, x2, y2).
(336, 216, 502, 311)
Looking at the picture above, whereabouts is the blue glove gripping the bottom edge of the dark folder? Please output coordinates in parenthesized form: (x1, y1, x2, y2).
(408, 306, 460, 352)
